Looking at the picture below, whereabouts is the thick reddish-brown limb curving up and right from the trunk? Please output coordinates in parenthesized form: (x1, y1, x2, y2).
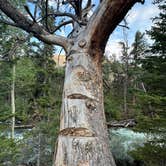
(86, 0, 143, 51)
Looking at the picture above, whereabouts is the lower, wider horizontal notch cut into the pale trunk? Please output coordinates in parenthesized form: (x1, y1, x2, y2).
(59, 127, 95, 137)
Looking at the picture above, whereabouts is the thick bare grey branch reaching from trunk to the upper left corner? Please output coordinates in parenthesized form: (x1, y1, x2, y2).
(0, 0, 69, 50)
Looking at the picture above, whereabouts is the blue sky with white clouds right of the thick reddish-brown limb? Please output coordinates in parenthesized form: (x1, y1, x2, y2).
(105, 0, 159, 59)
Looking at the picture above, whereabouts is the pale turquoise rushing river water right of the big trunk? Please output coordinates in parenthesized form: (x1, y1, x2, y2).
(109, 128, 146, 163)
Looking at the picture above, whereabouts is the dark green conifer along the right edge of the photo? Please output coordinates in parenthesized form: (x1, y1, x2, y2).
(131, 0, 166, 166)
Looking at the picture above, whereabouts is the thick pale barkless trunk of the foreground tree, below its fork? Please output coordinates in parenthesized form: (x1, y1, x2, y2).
(54, 51, 115, 166)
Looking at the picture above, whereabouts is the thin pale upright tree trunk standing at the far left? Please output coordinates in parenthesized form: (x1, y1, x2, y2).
(11, 55, 16, 139)
